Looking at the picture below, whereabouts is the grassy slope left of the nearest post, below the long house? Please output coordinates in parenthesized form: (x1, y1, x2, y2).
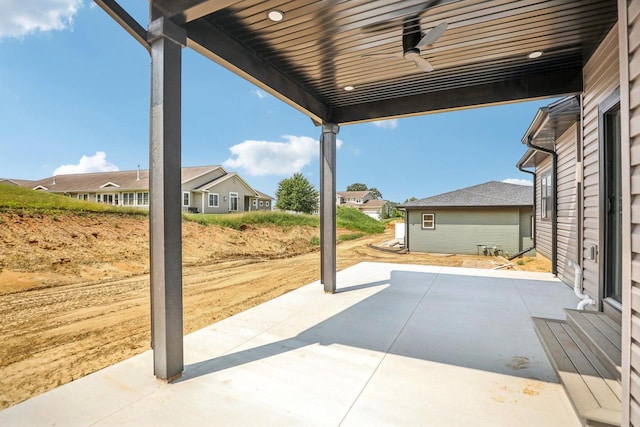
(0, 184, 148, 216)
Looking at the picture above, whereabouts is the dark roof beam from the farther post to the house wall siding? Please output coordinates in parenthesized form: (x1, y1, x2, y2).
(330, 66, 583, 124)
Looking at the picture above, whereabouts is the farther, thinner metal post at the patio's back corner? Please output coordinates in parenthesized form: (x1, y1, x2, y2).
(320, 123, 340, 294)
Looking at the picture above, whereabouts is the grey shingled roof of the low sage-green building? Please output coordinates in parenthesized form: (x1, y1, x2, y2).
(398, 181, 533, 209)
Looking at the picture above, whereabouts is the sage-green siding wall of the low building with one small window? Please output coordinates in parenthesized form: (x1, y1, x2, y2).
(408, 208, 530, 254)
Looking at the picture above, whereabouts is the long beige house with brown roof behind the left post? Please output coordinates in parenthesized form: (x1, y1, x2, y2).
(18, 166, 273, 213)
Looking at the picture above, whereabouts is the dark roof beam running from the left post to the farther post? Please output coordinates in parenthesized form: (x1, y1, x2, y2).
(184, 20, 328, 123)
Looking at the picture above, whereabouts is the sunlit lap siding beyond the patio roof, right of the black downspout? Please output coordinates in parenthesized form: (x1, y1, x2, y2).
(556, 124, 580, 285)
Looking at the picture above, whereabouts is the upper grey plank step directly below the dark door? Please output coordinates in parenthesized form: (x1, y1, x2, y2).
(565, 309, 622, 381)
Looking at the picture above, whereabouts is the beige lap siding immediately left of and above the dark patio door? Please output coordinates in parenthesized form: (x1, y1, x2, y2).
(582, 25, 620, 300)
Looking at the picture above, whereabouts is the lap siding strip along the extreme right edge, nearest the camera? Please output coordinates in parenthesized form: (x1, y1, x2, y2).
(622, 0, 640, 426)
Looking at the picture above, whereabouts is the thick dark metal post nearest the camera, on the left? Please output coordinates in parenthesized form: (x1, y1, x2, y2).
(148, 17, 186, 381)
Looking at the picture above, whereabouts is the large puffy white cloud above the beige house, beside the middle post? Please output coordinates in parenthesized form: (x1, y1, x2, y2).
(223, 135, 342, 176)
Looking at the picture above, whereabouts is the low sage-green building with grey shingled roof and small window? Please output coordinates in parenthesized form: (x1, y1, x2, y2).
(397, 181, 533, 254)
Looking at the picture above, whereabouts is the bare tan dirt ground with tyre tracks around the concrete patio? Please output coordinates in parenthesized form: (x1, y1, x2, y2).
(0, 213, 549, 409)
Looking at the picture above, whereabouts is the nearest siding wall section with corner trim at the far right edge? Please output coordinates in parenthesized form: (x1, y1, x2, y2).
(619, 0, 640, 426)
